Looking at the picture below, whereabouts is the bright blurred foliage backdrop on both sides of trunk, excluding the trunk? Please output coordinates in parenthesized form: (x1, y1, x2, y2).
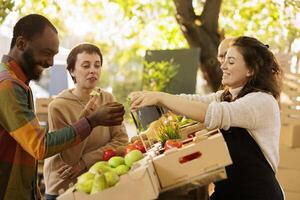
(0, 0, 300, 134)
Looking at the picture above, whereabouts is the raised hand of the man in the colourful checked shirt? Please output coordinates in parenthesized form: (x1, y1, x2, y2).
(86, 102, 125, 128)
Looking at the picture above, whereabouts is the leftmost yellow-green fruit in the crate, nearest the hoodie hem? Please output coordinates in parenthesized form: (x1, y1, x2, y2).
(75, 172, 95, 194)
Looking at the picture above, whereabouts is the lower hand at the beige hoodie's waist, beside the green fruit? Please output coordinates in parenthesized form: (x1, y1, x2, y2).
(57, 162, 85, 179)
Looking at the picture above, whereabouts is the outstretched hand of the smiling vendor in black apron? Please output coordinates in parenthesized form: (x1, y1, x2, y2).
(129, 91, 163, 111)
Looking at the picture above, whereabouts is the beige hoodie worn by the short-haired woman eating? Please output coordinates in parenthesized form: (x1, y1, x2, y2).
(44, 89, 128, 195)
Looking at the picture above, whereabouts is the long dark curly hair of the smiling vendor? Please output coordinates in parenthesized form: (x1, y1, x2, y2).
(221, 36, 282, 101)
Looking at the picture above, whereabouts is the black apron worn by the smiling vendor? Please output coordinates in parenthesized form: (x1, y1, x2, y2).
(211, 127, 283, 200)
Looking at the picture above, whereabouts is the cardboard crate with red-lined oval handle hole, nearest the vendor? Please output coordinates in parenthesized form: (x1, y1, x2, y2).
(153, 130, 232, 189)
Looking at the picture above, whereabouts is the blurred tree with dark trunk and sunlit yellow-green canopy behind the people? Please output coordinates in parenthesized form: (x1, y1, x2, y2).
(0, 0, 300, 92)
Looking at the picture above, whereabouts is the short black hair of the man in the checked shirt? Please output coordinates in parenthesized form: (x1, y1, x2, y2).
(10, 14, 58, 49)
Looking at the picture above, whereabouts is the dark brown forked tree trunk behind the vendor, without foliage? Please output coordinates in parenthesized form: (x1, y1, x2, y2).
(174, 0, 222, 91)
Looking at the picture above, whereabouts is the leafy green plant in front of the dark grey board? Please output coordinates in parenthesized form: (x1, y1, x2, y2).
(143, 60, 179, 91)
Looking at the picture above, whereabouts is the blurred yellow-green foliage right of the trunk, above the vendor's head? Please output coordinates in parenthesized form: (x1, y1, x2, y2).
(219, 0, 300, 52)
